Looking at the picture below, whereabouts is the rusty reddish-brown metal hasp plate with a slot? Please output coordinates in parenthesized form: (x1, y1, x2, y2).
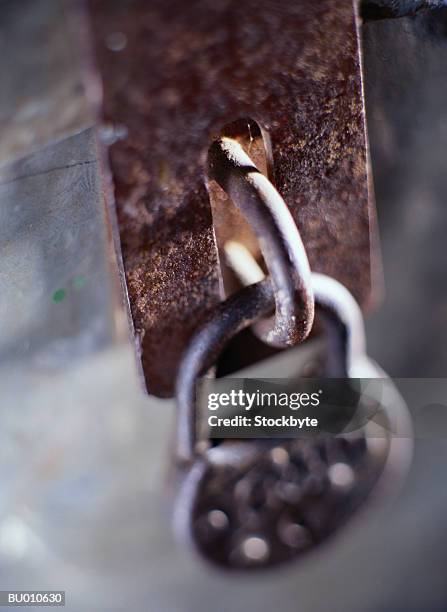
(90, 0, 371, 395)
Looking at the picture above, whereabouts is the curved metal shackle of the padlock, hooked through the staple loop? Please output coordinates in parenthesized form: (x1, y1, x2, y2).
(177, 274, 365, 461)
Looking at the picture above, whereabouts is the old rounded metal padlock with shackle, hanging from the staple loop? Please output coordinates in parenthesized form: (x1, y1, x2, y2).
(174, 274, 412, 570)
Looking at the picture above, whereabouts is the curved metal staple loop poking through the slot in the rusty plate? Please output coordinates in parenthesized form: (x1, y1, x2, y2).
(208, 138, 314, 347)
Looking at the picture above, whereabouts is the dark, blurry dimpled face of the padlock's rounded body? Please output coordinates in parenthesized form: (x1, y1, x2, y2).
(184, 426, 388, 570)
